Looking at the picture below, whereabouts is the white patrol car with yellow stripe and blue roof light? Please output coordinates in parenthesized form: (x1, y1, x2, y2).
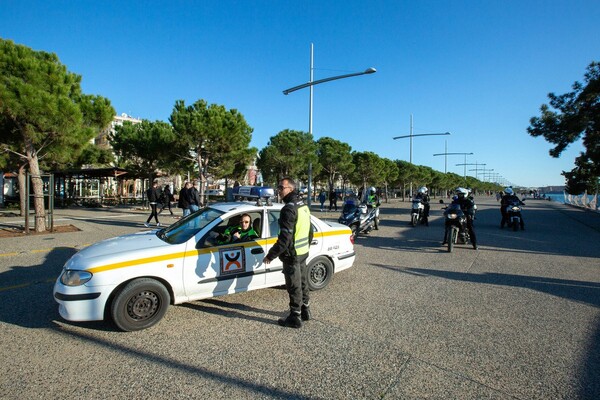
(54, 187, 355, 331)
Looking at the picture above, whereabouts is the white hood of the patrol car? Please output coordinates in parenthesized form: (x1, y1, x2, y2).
(66, 231, 173, 269)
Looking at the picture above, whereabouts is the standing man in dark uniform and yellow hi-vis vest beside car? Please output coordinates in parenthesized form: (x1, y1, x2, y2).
(263, 178, 312, 328)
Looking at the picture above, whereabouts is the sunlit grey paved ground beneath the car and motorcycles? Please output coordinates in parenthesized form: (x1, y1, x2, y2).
(0, 198, 600, 399)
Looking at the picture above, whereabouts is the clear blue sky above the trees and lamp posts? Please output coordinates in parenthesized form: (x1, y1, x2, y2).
(0, 0, 600, 186)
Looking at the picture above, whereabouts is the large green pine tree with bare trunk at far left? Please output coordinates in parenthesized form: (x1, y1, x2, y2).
(0, 39, 115, 232)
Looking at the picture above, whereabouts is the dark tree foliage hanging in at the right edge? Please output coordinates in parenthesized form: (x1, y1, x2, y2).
(527, 62, 600, 194)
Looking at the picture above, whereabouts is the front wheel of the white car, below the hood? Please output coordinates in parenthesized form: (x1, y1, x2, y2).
(111, 278, 170, 332)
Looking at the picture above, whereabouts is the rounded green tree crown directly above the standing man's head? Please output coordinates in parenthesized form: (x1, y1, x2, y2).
(257, 129, 320, 183)
